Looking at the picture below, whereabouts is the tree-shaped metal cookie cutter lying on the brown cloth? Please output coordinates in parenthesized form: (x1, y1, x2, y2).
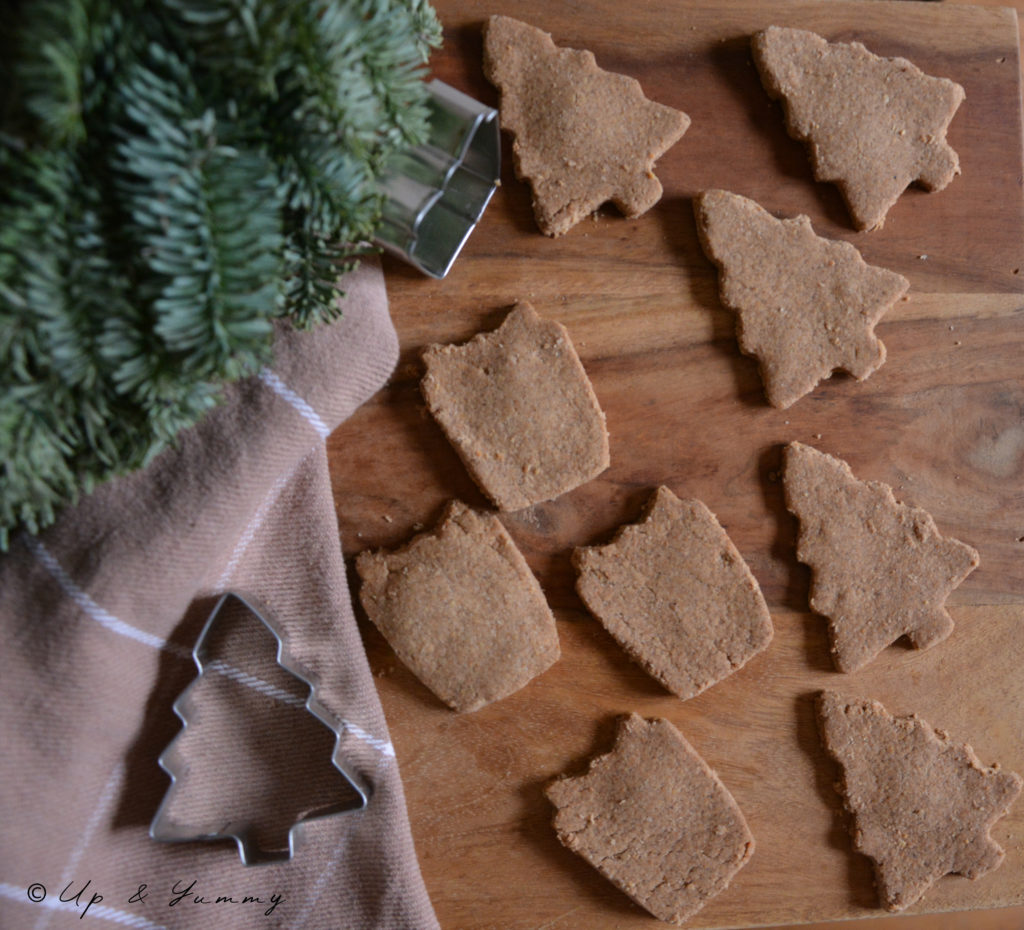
(150, 592, 370, 865)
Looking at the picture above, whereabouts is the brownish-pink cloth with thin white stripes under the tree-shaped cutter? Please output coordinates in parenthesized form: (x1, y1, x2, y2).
(0, 261, 437, 930)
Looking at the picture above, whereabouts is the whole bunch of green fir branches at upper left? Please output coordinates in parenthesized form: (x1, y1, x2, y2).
(0, 0, 439, 548)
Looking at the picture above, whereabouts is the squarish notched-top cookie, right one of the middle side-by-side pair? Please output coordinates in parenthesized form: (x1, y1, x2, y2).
(572, 488, 772, 701)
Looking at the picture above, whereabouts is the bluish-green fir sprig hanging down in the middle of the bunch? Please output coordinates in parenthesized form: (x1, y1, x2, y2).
(114, 46, 283, 381)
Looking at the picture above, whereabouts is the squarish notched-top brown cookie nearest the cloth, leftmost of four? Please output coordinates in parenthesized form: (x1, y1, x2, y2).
(355, 501, 559, 712)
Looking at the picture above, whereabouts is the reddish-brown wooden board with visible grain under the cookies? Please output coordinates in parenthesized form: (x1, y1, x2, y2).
(330, 0, 1024, 930)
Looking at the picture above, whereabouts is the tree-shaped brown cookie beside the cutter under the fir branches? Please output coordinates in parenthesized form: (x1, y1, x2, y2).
(483, 16, 690, 236)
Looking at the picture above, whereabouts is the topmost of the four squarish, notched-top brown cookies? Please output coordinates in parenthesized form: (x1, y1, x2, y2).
(421, 302, 608, 510)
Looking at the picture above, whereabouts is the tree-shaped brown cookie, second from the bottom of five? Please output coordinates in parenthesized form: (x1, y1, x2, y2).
(784, 442, 978, 672)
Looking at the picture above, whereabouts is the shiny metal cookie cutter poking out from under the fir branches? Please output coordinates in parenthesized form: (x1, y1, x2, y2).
(377, 80, 501, 278)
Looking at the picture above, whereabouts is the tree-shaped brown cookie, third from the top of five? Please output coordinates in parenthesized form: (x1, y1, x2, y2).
(694, 191, 908, 408)
